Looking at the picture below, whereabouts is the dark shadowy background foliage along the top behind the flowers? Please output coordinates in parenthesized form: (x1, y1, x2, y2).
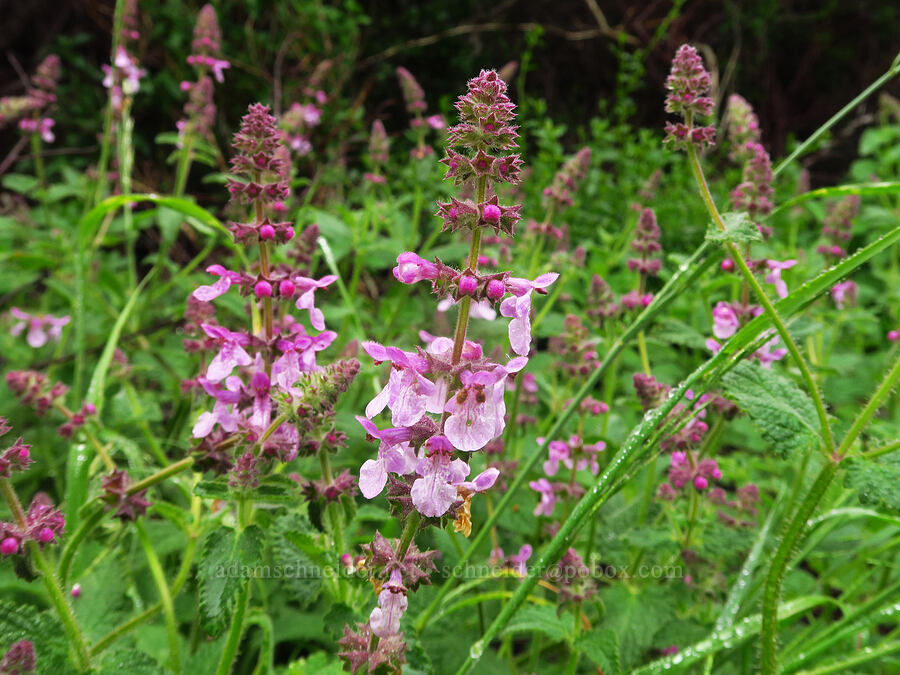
(0, 0, 900, 184)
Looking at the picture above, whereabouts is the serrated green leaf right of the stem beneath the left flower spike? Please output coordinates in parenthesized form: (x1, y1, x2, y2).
(272, 513, 323, 608)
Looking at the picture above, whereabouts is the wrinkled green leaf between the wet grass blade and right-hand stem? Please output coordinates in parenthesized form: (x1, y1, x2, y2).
(722, 362, 819, 457)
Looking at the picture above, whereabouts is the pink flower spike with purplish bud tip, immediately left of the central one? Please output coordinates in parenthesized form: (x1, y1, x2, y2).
(186, 104, 350, 492)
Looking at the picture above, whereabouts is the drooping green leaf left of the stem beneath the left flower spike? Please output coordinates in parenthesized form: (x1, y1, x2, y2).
(197, 525, 265, 635)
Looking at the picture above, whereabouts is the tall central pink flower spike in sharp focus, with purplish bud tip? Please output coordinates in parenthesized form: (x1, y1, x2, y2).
(340, 71, 558, 672)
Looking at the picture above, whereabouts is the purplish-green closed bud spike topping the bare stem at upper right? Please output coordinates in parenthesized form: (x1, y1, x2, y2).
(664, 45, 716, 150)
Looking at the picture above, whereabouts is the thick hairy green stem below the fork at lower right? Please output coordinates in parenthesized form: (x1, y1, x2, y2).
(760, 459, 840, 675)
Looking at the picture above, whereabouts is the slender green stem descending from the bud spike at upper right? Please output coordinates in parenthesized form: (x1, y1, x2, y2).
(688, 145, 834, 454)
